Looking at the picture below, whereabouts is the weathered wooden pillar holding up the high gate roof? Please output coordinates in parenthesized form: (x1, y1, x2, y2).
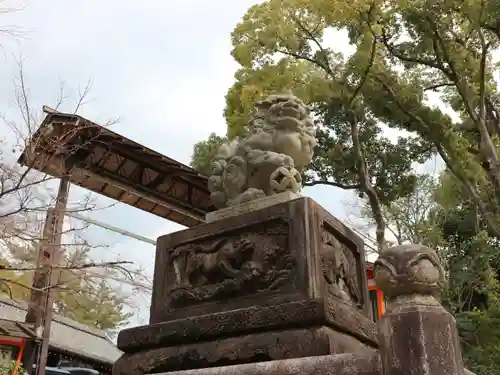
(25, 176, 70, 375)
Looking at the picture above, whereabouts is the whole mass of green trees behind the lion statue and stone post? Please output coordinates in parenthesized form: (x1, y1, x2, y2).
(192, 0, 500, 374)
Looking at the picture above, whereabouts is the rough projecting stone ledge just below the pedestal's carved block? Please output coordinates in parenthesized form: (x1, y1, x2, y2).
(118, 299, 376, 353)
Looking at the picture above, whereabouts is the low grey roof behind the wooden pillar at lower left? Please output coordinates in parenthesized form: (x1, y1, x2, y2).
(0, 295, 122, 364)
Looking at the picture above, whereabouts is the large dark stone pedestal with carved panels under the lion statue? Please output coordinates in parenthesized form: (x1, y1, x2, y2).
(113, 198, 377, 375)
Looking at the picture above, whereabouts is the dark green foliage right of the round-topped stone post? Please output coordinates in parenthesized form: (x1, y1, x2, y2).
(433, 177, 500, 375)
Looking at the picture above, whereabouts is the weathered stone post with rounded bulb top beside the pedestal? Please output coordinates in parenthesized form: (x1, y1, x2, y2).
(374, 245, 464, 375)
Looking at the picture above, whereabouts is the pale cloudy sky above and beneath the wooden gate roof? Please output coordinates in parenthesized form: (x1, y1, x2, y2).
(0, 0, 438, 324)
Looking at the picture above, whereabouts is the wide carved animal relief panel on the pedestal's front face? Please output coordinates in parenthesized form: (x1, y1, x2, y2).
(167, 220, 295, 307)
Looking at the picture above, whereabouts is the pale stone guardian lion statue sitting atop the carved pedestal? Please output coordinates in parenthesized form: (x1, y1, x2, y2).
(208, 95, 316, 208)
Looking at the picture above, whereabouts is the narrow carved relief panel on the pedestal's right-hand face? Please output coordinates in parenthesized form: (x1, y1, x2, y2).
(321, 227, 364, 308)
